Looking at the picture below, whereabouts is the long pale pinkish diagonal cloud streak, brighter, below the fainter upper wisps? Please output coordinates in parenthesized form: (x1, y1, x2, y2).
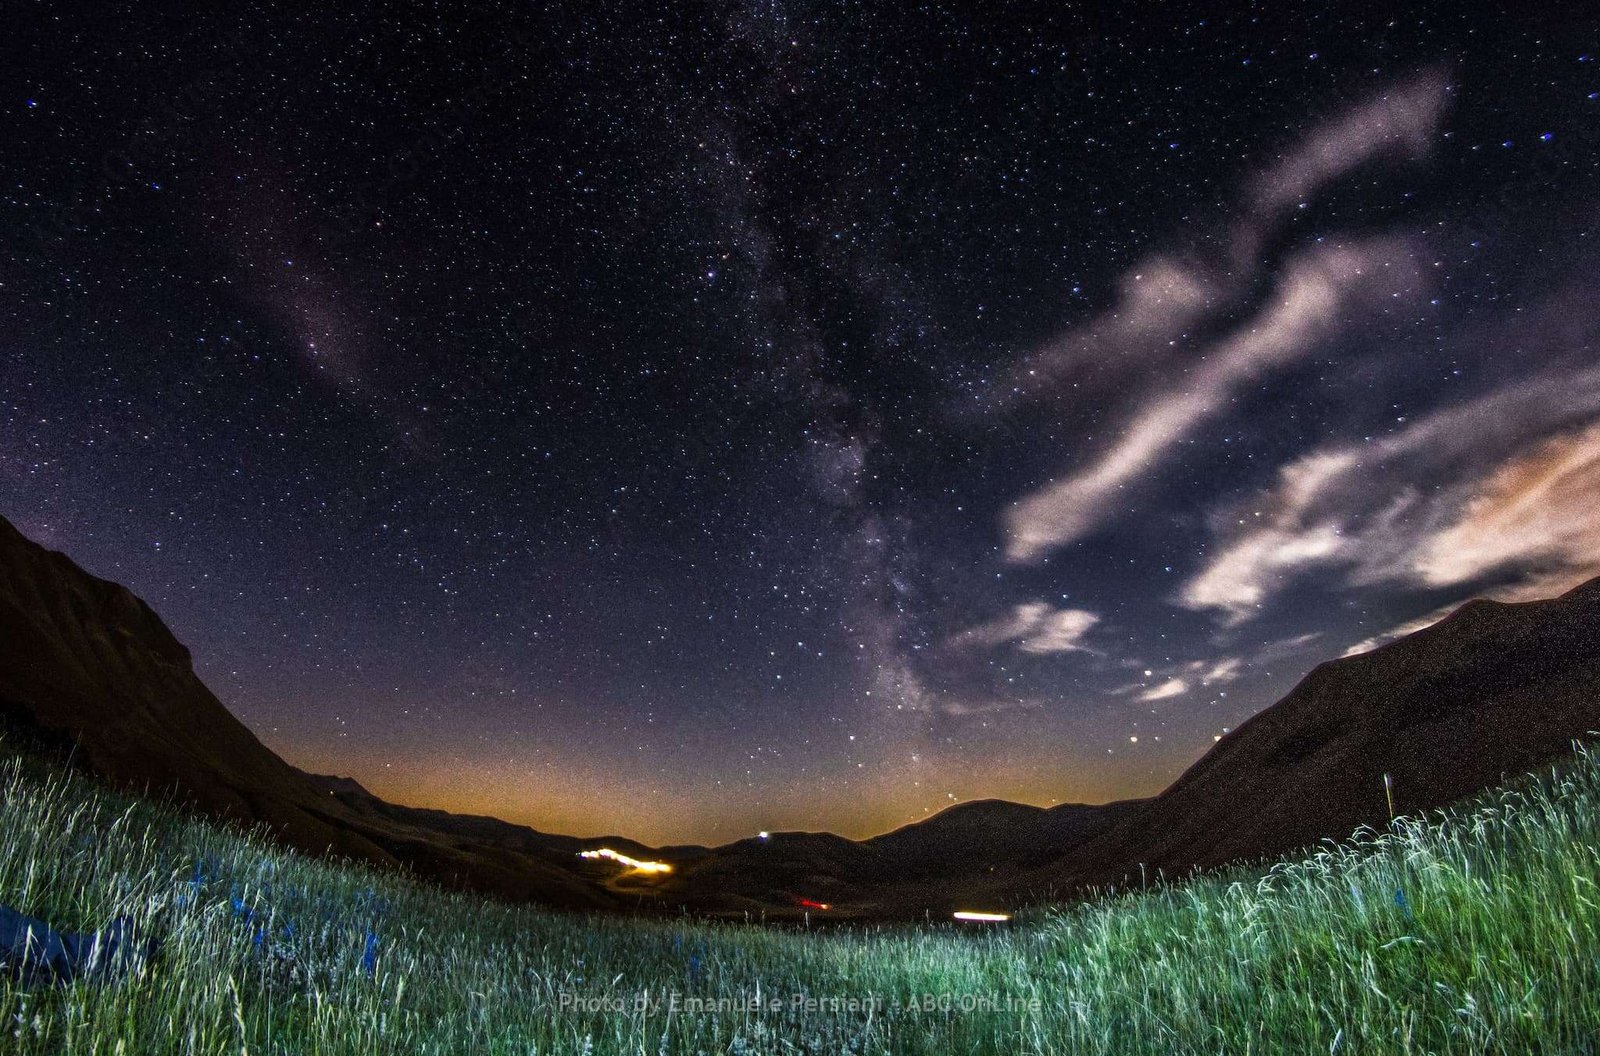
(1005, 240, 1418, 562)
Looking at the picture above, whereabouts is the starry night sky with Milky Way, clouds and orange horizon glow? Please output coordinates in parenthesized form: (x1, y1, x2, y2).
(0, 0, 1600, 843)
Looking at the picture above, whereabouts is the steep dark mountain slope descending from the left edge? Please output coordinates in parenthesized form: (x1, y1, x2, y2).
(0, 517, 613, 906)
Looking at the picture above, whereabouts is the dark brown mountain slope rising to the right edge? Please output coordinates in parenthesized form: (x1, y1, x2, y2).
(1029, 579, 1600, 888)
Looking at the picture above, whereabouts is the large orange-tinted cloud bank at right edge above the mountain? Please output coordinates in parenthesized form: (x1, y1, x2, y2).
(1178, 361, 1600, 627)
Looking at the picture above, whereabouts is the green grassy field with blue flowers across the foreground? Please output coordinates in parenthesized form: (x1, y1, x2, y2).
(0, 752, 1600, 1056)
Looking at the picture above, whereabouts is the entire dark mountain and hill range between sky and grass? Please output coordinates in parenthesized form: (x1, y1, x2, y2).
(0, 518, 1600, 918)
